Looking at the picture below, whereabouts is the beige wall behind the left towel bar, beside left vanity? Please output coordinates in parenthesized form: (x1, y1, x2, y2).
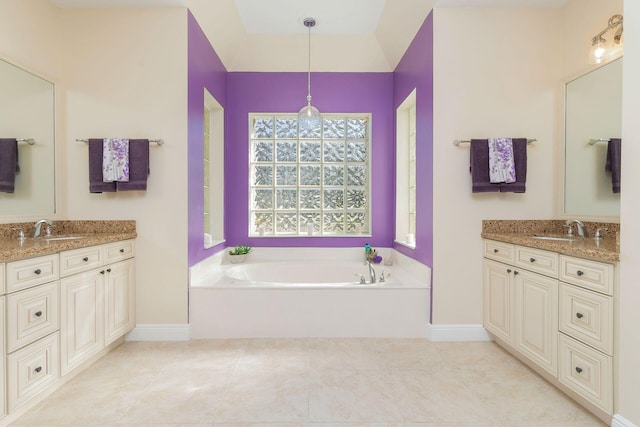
(62, 8, 187, 324)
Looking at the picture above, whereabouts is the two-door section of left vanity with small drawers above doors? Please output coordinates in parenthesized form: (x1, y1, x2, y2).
(60, 240, 135, 375)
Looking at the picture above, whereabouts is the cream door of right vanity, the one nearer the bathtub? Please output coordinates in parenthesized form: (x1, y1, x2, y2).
(483, 259, 513, 343)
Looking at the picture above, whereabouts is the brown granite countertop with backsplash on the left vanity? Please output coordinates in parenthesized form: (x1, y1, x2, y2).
(0, 221, 137, 262)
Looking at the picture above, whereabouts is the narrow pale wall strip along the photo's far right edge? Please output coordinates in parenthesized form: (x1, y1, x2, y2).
(618, 0, 640, 426)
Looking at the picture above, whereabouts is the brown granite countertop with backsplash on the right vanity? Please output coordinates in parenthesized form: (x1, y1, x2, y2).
(481, 220, 620, 262)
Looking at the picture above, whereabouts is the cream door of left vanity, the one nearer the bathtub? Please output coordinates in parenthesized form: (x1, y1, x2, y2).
(105, 259, 136, 345)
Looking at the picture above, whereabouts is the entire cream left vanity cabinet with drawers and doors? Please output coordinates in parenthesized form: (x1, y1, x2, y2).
(0, 240, 135, 424)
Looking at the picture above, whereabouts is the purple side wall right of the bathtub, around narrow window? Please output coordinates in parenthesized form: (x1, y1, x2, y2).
(391, 12, 433, 267)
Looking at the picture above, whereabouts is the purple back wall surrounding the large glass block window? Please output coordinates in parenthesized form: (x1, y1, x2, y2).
(225, 73, 395, 247)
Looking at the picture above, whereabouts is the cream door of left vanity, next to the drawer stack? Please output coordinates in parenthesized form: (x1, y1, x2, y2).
(60, 270, 105, 375)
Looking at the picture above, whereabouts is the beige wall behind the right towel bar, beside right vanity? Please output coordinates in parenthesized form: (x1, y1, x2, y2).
(433, 8, 562, 324)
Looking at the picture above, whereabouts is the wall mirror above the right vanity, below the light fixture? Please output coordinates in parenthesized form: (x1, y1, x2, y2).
(563, 58, 624, 217)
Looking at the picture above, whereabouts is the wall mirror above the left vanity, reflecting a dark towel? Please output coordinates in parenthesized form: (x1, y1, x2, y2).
(0, 60, 56, 217)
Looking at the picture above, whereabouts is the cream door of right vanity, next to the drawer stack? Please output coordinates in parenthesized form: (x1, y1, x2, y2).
(514, 269, 558, 375)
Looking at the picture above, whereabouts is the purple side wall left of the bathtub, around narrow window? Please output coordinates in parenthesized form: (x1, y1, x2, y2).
(187, 12, 227, 266)
